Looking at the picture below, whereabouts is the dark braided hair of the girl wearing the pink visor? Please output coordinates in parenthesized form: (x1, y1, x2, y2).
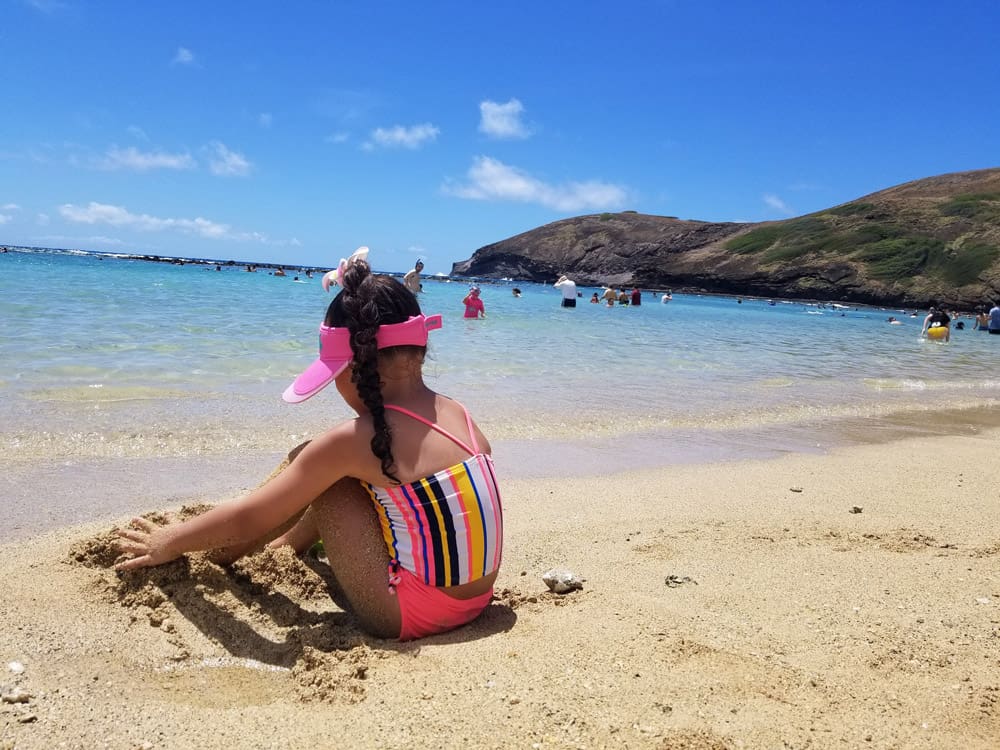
(326, 260, 427, 484)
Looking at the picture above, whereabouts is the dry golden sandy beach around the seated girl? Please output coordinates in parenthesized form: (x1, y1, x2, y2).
(0, 430, 1000, 750)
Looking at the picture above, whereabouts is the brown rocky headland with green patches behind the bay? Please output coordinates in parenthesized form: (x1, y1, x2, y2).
(452, 169, 1000, 309)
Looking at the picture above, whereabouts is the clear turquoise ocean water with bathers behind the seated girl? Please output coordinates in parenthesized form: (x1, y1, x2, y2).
(0, 252, 1000, 484)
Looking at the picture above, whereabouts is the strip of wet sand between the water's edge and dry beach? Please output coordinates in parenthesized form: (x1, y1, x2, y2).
(7, 407, 1000, 544)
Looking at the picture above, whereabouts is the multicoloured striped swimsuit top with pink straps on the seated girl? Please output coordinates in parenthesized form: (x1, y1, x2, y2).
(362, 404, 503, 587)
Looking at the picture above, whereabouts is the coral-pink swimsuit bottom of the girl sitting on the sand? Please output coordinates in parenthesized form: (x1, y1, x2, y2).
(389, 561, 493, 641)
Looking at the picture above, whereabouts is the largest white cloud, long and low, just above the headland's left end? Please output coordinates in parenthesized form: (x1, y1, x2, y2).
(444, 156, 627, 211)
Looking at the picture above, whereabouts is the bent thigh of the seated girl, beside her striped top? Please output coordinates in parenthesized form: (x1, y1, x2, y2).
(308, 478, 402, 638)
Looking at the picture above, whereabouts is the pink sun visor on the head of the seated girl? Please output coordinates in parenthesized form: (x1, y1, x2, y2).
(281, 315, 441, 404)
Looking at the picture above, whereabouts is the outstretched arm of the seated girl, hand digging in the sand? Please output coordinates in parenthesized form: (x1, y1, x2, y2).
(115, 420, 370, 570)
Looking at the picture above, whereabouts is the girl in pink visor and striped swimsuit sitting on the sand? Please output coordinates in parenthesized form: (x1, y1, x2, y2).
(118, 256, 503, 640)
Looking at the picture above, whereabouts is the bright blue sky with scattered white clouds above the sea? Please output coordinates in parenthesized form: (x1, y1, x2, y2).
(0, 0, 1000, 273)
